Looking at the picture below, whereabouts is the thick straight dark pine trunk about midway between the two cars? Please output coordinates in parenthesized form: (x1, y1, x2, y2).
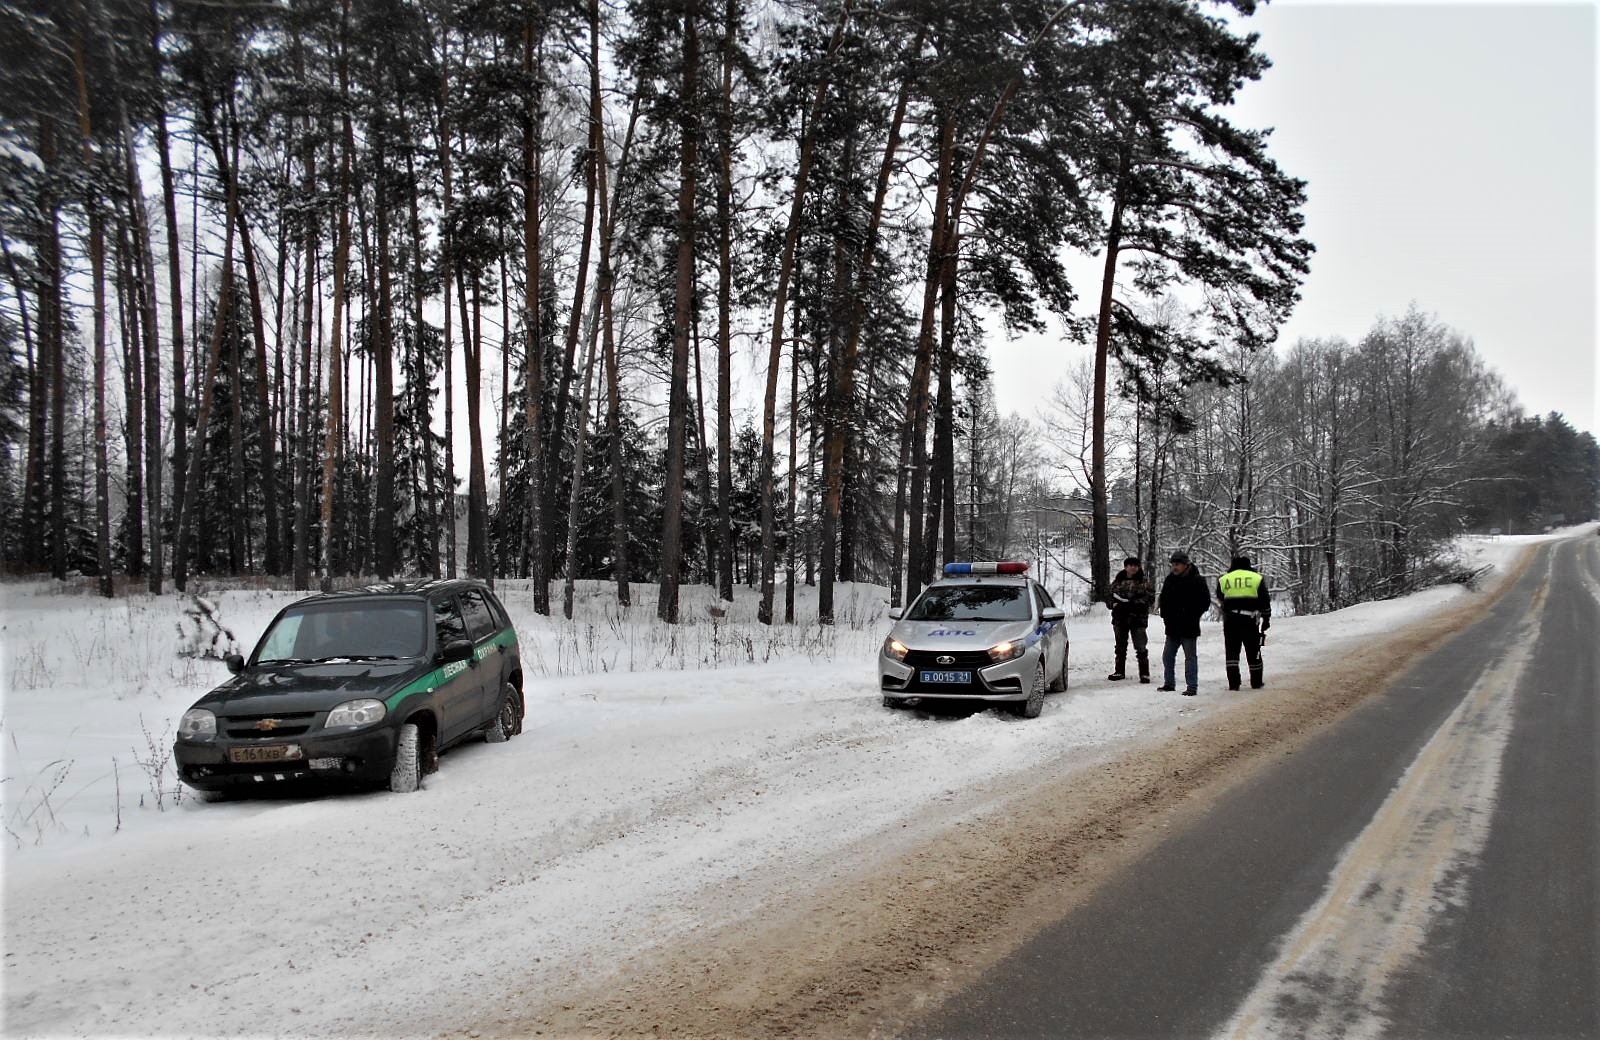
(656, 0, 704, 624)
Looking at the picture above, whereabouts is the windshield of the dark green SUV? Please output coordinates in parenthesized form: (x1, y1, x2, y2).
(256, 600, 427, 664)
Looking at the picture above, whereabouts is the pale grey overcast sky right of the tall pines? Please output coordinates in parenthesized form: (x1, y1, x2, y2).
(990, 0, 1600, 430)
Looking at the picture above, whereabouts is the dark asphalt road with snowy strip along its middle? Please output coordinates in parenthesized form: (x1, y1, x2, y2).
(915, 534, 1600, 1038)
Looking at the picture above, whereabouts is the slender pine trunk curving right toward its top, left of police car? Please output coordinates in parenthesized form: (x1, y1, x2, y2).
(757, 0, 851, 624)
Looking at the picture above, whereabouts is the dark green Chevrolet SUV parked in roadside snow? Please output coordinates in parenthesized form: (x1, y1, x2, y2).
(173, 581, 523, 794)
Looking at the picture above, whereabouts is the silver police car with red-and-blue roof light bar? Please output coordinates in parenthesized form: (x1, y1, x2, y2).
(878, 562, 1069, 718)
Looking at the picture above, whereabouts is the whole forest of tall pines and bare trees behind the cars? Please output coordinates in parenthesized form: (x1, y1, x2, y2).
(0, 0, 1594, 621)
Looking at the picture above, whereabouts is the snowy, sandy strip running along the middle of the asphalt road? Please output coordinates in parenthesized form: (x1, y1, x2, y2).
(1218, 554, 1554, 1040)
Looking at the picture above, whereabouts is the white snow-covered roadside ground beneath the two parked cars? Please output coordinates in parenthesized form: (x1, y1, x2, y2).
(0, 528, 1592, 1035)
